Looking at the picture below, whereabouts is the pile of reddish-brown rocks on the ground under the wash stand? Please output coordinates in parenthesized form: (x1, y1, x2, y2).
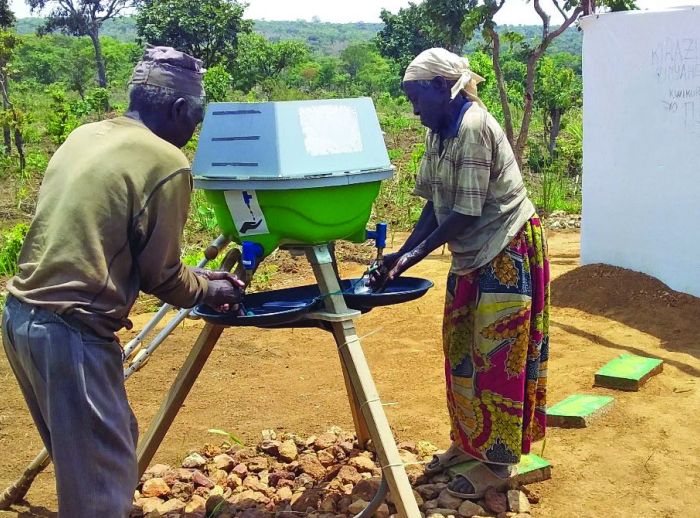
(131, 428, 530, 518)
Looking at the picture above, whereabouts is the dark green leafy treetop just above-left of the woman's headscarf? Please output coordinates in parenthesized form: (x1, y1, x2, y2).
(375, 2, 442, 72)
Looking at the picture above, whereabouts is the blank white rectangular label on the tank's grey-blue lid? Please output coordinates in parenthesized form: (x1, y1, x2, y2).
(299, 104, 362, 156)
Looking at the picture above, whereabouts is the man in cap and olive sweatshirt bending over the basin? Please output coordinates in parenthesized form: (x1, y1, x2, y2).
(3, 47, 242, 518)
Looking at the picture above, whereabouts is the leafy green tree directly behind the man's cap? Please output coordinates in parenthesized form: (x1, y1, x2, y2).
(136, 0, 252, 66)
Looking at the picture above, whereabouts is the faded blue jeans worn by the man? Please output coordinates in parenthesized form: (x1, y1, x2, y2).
(2, 297, 138, 518)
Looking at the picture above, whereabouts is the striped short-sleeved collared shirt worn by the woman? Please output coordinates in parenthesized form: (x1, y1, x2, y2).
(414, 104, 535, 275)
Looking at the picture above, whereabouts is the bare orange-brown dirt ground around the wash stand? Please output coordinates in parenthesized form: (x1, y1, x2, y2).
(0, 233, 700, 517)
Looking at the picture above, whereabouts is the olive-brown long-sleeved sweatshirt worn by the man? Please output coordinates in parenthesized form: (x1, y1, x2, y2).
(7, 117, 207, 337)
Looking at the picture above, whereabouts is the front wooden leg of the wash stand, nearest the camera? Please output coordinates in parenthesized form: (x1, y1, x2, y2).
(307, 245, 420, 518)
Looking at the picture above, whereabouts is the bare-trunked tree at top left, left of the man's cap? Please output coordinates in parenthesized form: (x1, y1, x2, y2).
(26, 0, 134, 88)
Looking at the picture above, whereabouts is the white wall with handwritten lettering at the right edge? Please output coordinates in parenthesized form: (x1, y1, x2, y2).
(581, 6, 700, 296)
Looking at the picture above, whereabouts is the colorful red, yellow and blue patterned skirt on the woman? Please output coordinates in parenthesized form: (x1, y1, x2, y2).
(443, 216, 549, 464)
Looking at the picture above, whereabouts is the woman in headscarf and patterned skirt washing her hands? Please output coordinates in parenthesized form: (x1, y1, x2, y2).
(372, 49, 549, 498)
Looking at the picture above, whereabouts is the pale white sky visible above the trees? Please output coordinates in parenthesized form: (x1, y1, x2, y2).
(12, 0, 700, 25)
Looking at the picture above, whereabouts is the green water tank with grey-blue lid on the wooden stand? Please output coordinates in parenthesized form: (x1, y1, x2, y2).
(192, 98, 393, 255)
